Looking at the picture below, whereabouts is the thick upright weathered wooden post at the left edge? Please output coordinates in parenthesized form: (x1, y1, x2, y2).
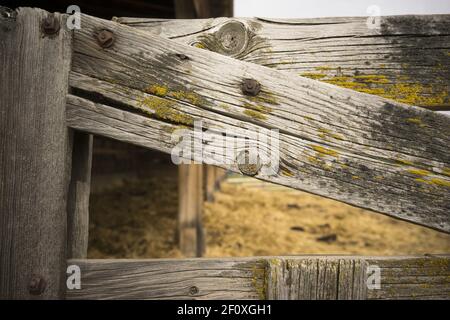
(0, 8, 72, 299)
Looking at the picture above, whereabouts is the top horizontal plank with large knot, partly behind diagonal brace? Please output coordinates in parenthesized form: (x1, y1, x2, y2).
(115, 15, 450, 110)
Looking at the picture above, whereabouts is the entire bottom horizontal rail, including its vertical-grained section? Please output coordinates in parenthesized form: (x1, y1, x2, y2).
(67, 256, 450, 300)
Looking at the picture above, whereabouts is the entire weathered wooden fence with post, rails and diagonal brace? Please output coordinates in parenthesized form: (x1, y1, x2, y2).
(0, 8, 450, 299)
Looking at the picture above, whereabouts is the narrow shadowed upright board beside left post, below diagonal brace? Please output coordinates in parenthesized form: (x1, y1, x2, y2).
(67, 131, 93, 259)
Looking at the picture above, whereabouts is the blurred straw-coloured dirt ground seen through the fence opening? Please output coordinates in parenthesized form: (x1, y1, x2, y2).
(88, 171, 450, 258)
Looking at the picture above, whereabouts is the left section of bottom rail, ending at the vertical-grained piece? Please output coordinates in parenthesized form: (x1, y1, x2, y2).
(67, 259, 264, 299)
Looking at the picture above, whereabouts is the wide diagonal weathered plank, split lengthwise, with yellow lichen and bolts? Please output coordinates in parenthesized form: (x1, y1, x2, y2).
(67, 15, 450, 232)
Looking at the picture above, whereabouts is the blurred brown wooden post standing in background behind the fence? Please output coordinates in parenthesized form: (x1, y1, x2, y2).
(178, 164, 205, 257)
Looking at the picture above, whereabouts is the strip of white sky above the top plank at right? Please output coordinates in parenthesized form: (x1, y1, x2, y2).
(234, 0, 450, 18)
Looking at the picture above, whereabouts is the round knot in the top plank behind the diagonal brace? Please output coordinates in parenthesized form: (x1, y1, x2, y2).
(216, 21, 248, 56)
